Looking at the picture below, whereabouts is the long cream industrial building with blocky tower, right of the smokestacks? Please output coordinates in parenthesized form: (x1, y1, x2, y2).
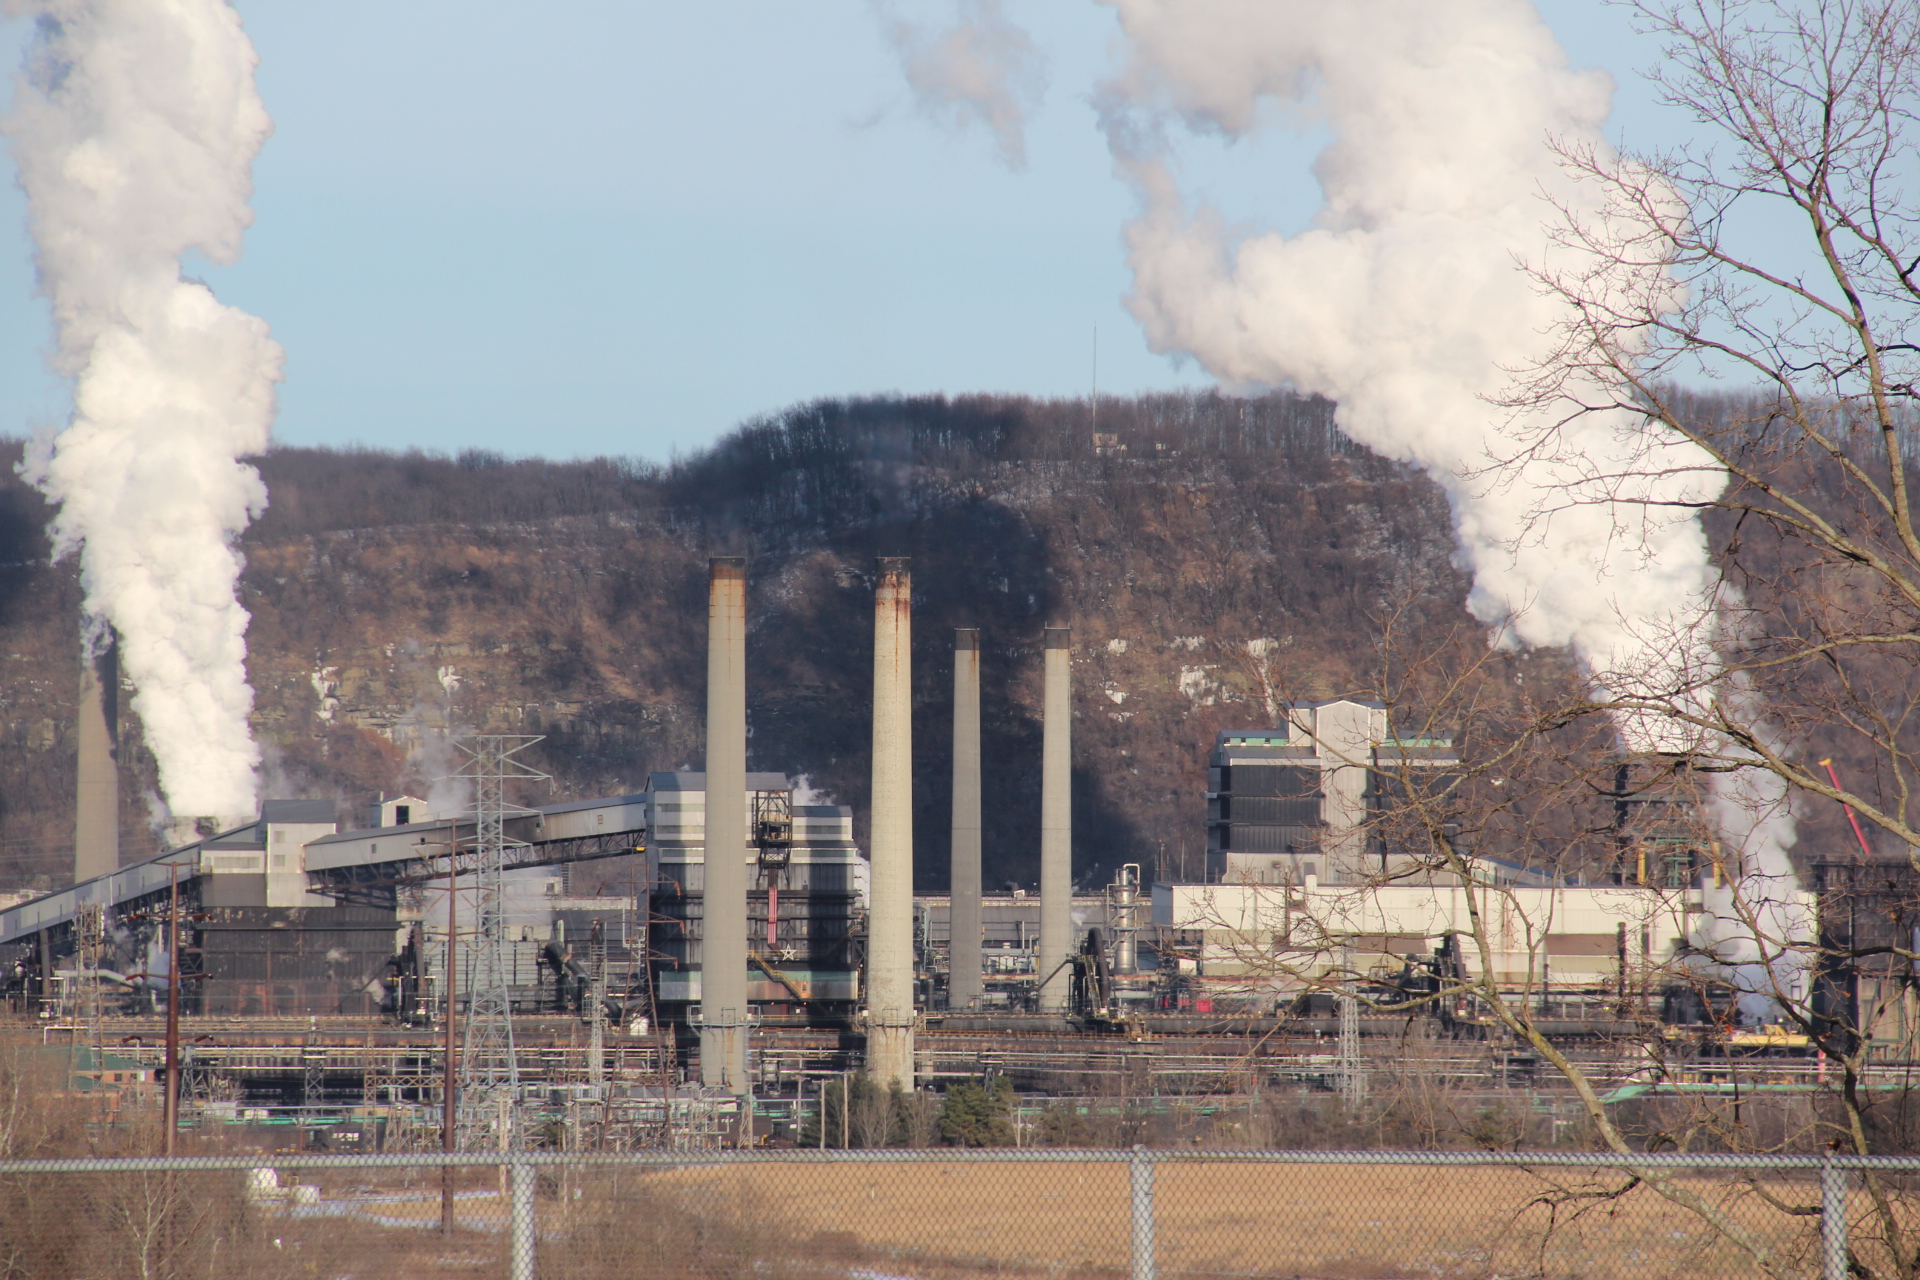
(1175, 721, 1820, 1021)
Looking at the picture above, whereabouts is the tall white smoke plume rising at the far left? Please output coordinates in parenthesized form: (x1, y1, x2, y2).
(6, 0, 282, 818)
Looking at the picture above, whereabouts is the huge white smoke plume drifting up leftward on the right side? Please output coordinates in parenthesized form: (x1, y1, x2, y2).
(1106, 0, 1793, 1013)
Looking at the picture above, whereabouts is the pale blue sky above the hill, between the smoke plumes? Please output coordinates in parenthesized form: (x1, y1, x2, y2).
(0, 0, 1697, 459)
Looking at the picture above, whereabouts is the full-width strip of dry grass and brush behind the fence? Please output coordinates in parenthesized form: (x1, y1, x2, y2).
(0, 1157, 1868, 1280)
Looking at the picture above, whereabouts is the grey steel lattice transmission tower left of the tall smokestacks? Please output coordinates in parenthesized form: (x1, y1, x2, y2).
(455, 733, 547, 1151)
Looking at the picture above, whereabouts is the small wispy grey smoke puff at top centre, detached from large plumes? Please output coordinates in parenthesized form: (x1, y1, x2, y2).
(879, 0, 1046, 169)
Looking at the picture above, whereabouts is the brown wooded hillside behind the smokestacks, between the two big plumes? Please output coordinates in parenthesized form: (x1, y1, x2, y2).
(0, 393, 1497, 889)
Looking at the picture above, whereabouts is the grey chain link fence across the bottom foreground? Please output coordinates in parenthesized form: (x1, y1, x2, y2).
(0, 1150, 1920, 1280)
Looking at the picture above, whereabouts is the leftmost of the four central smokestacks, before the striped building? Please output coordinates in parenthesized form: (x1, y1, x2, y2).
(701, 557, 749, 1094)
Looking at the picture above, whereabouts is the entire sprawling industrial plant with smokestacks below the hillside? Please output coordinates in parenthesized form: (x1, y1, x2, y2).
(0, 558, 1914, 1150)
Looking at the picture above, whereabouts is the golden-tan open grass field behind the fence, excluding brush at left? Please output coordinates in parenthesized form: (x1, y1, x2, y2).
(541, 1159, 1812, 1280)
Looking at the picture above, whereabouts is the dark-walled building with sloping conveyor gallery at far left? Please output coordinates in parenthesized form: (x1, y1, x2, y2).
(0, 794, 647, 1017)
